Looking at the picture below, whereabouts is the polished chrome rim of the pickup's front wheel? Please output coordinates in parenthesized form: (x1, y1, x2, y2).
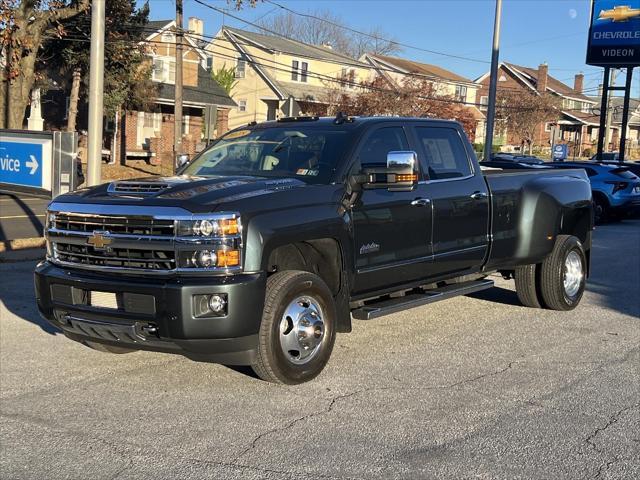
(280, 295, 325, 365)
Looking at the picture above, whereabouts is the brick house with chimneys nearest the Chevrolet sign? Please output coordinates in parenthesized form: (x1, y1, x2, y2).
(476, 62, 599, 156)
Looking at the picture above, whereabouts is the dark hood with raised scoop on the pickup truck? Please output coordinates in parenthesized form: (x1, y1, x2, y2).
(55, 175, 307, 211)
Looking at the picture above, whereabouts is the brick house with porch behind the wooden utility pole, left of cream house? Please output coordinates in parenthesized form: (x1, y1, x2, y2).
(116, 17, 236, 165)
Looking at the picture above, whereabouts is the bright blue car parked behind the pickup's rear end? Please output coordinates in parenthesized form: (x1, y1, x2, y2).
(549, 162, 640, 223)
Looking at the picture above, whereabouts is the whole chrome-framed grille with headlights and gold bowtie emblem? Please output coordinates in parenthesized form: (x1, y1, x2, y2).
(46, 202, 242, 275)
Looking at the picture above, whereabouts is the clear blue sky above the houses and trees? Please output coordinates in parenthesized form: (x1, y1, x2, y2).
(139, 0, 640, 96)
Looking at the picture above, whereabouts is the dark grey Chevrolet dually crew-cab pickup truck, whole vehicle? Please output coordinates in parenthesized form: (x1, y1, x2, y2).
(35, 115, 593, 384)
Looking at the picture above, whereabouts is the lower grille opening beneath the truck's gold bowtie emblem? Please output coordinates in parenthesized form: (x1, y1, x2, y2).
(53, 242, 176, 270)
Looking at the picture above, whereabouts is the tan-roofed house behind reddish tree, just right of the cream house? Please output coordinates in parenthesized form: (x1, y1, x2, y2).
(360, 53, 486, 141)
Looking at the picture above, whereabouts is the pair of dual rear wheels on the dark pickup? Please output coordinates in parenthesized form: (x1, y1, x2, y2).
(515, 235, 587, 310)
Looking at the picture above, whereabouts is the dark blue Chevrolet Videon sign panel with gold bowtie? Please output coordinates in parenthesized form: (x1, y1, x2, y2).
(587, 0, 640, 67)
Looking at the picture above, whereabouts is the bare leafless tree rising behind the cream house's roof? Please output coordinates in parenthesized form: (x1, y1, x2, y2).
(259, 10, 401, 58)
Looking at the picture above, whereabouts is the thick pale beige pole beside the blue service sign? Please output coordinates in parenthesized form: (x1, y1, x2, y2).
(87, 0, 105, 186)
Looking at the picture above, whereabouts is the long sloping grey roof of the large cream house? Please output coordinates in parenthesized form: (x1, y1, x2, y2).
(223, 27, 369, 68)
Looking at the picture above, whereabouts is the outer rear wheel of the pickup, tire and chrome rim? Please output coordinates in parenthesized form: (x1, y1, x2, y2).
(540, 235, 587, 311)
